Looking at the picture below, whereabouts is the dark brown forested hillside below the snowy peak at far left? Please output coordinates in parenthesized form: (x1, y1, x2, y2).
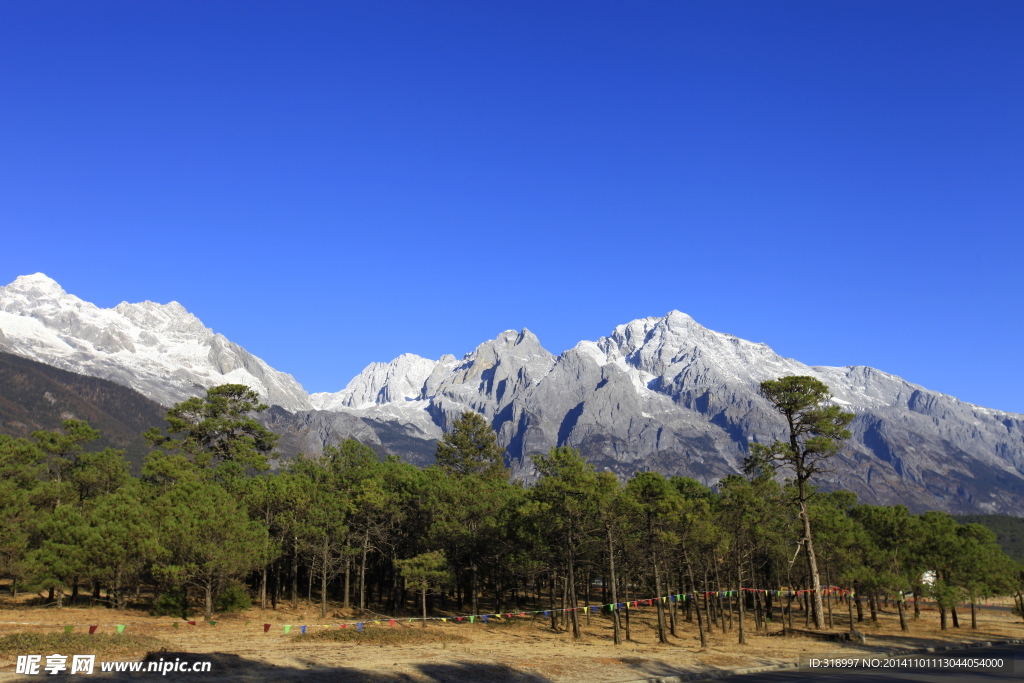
(0, 352, 166, 471)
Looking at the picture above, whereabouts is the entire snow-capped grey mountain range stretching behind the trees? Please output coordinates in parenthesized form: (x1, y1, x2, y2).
(0, 274, 1024, 514)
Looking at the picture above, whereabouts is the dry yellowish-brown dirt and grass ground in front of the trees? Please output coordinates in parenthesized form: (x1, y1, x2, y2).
(0, 600, 1024, 683)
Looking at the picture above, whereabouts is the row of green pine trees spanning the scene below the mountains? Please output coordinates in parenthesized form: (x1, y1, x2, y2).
(0, 378, 1020, 642)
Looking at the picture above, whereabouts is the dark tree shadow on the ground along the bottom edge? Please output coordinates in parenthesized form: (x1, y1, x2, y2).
(78, 652, 551, 683)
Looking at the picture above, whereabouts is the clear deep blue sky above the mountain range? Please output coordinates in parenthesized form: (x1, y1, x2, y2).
(0, 0, 1024, 413)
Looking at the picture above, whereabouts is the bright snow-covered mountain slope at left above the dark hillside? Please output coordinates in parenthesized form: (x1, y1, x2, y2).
(0, 273, 310, 411)
